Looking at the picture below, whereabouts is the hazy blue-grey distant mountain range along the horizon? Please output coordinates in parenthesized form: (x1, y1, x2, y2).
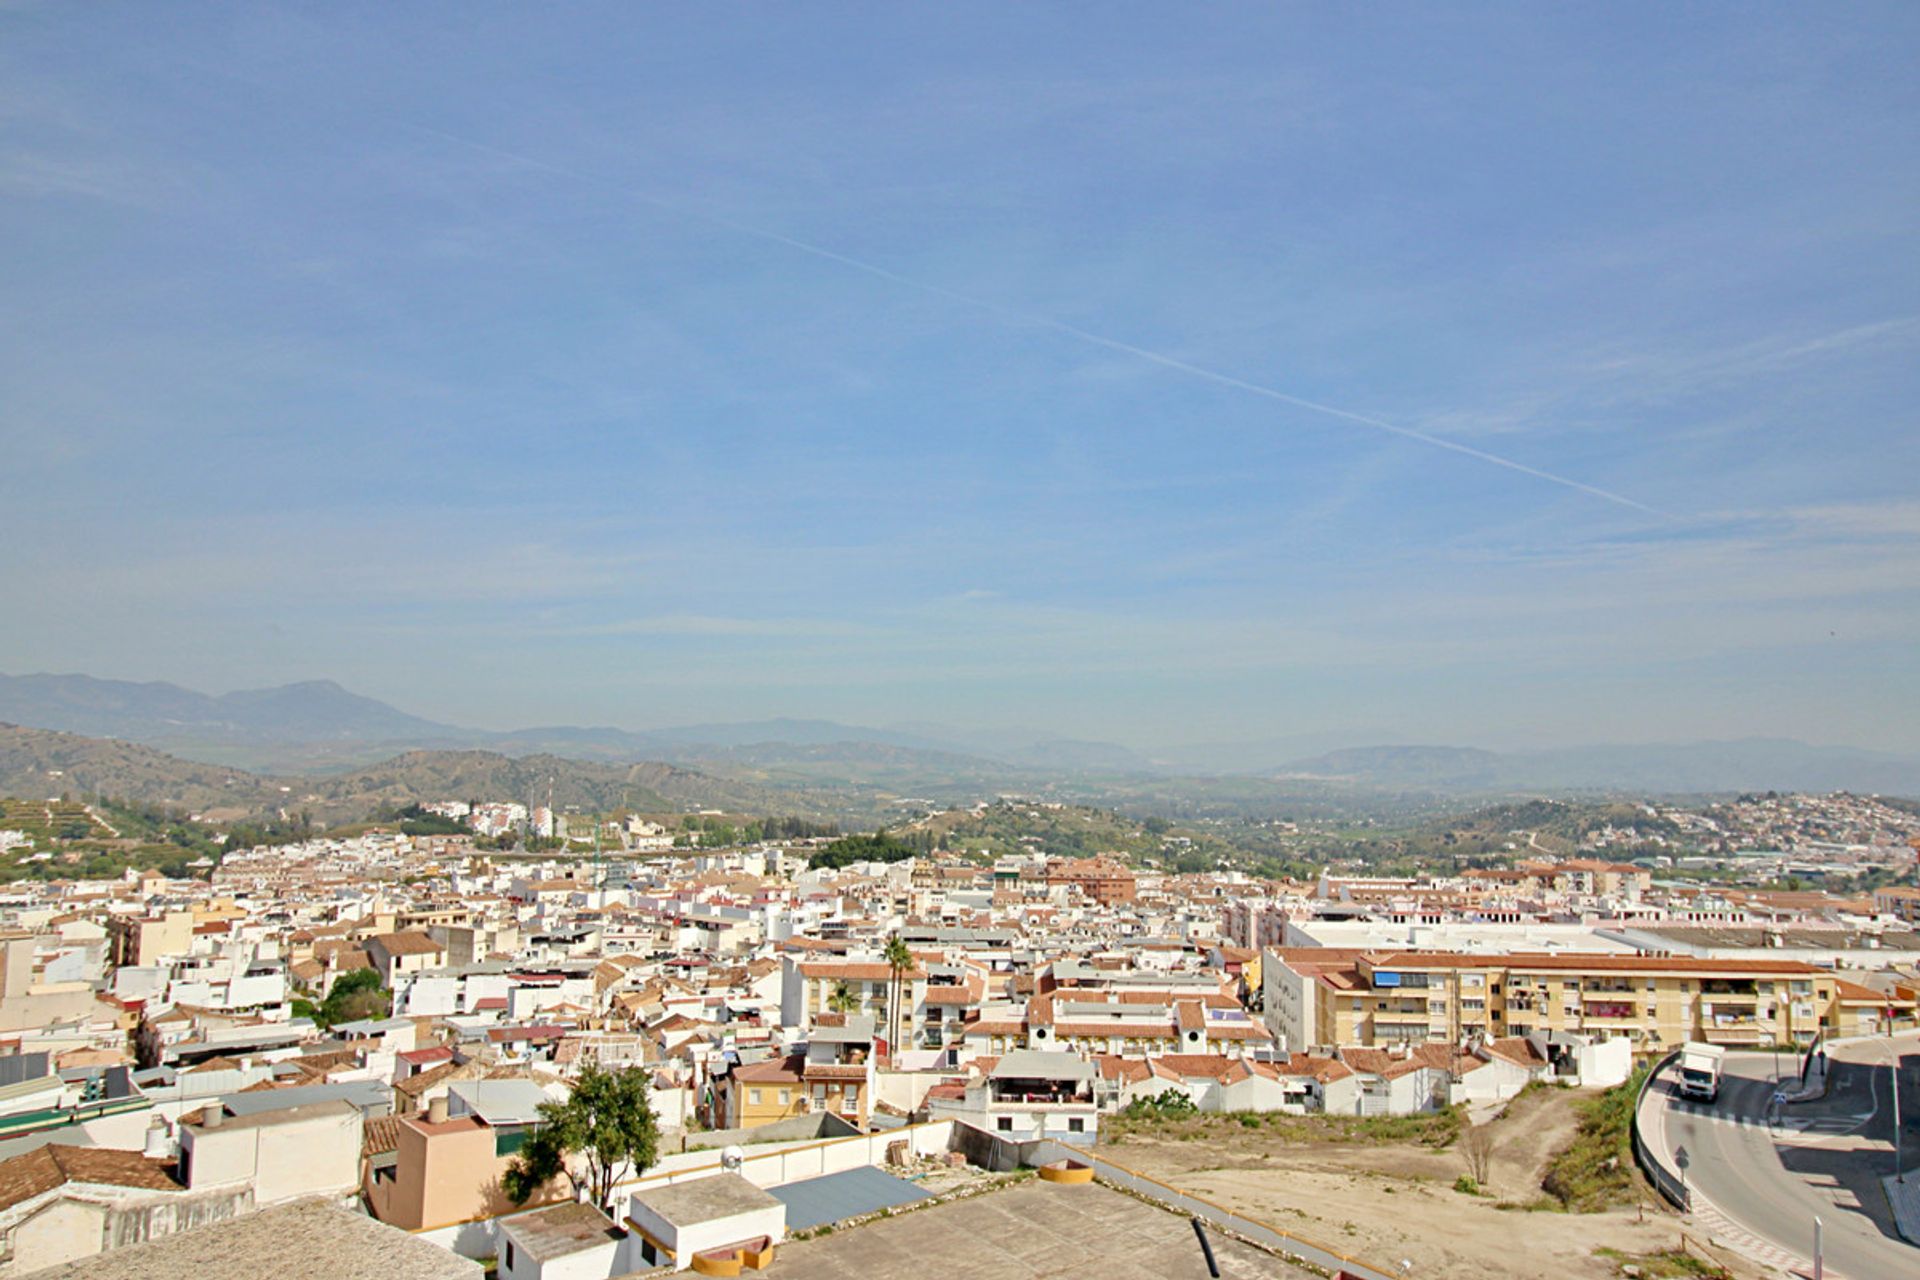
(0, 676, 1920, 812)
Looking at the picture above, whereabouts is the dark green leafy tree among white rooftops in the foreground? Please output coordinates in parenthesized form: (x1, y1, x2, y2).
(501, 1065, 660, 1211)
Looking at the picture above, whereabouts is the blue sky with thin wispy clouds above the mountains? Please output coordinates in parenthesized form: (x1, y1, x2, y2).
(0, 2, 1920, 750)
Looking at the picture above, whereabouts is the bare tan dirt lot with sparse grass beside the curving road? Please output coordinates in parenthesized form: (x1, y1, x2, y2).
(1100, 1090, 1745, 1280)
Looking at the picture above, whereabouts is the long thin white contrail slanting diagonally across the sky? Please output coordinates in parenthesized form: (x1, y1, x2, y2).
(413, 125, 1668, 516)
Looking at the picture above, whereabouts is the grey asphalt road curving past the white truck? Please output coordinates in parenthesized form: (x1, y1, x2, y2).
(1649, 1046, 1920, 1280)
